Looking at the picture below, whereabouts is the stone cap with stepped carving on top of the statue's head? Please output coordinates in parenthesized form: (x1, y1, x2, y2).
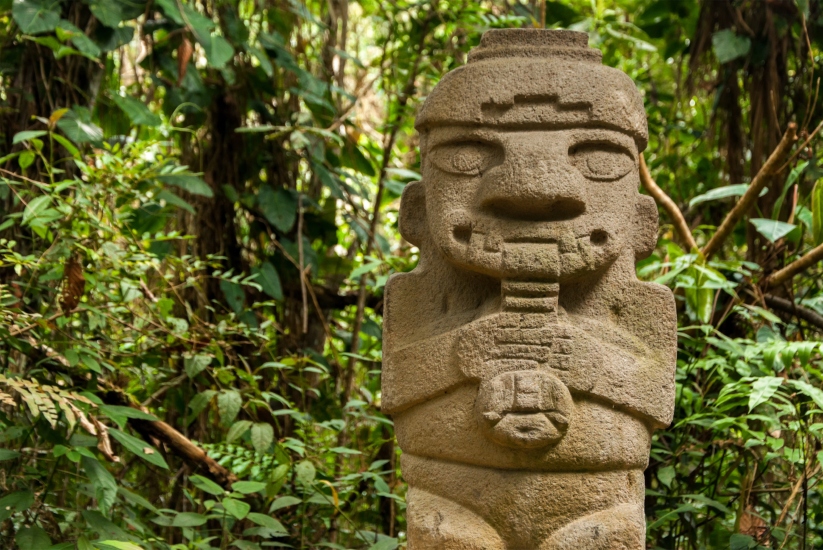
(415, 29, 648, 151)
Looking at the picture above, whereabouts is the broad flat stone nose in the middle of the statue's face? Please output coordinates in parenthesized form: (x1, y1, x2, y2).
(481, 157, 586, 221)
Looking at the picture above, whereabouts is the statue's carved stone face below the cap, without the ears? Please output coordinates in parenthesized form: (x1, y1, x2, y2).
(423, 126, 640, 282)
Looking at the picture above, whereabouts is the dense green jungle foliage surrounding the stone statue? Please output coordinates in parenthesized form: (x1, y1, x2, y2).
(0, 0, 823, 550)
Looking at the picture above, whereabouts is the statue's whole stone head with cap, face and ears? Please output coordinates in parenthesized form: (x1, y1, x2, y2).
(400, 29, 657, 283)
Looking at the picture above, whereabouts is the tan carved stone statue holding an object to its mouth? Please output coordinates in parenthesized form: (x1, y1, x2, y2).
(382, 29, 677, 550)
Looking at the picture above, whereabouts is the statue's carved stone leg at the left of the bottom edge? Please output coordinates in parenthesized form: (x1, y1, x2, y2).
(406, 487, 506, 550)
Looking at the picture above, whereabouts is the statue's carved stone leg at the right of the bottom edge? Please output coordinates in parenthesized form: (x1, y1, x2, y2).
(540, 504, 646, 550)
